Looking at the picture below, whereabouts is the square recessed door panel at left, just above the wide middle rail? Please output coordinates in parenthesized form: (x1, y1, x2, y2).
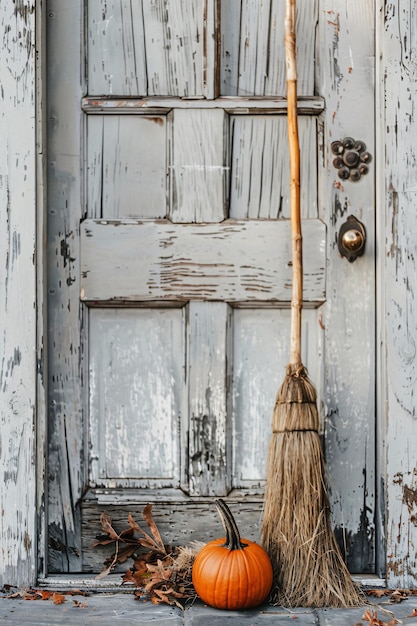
(87, 115, 168, 219)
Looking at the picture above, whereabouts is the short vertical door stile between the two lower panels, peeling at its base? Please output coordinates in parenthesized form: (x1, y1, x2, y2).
(188, 302, 230, 496)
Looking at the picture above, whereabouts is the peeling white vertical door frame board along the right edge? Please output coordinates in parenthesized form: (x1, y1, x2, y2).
(380, 0, 417, 588)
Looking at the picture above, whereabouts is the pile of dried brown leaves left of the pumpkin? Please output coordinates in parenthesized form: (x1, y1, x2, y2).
(93, 504, 203, 608)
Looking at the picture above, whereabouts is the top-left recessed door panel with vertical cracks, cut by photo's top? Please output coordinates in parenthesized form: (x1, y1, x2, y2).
(87, 0, 210, 97)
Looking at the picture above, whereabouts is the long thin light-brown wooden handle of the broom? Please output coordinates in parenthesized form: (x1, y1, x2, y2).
(284, 0, 303, 365)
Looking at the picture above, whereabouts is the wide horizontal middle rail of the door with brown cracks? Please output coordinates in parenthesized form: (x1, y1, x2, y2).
(81, 220, 325, 304)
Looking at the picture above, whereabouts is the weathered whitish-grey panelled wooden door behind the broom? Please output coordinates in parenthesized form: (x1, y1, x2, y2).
(47, 0, 376, 573)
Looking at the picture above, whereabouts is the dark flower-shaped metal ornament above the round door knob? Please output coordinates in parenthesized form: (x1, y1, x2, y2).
(330, 137, 372, 182)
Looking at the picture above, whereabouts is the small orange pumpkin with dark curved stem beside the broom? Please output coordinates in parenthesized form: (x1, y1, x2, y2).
(192, 499, 273, 610)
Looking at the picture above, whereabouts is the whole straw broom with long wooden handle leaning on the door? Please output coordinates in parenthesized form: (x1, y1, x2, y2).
(261, 0, 363, 607)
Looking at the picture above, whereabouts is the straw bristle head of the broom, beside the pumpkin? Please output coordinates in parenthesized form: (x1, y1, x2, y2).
(262, 365, 363, 607)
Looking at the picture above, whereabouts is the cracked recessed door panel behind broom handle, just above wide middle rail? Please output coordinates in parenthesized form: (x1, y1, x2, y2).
(230, 115, 317, 219)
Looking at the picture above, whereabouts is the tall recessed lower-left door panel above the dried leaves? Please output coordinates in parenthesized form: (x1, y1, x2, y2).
(88, 308, 186, 488)
